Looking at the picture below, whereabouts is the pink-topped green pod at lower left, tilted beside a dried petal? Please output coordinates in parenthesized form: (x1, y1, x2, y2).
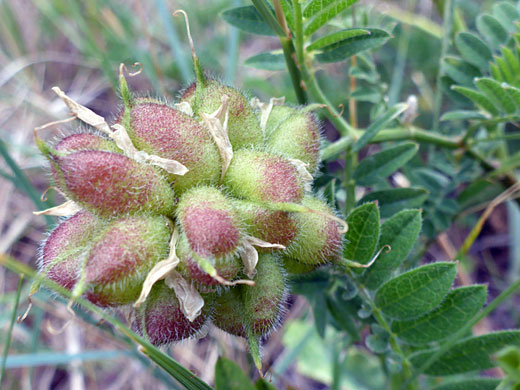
(85, 216, 170, 306)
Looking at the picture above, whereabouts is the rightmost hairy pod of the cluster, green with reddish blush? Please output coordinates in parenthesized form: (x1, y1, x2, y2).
(286, 196, 342, 265)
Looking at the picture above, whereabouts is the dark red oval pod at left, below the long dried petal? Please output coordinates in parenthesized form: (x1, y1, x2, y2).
(54, 151, 175, 216)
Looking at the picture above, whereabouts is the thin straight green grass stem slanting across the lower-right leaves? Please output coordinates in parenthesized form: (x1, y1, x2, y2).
(408, 280, 520, 382)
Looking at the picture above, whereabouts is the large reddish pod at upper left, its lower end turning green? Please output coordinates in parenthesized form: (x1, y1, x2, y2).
(128, 101, 222, 192)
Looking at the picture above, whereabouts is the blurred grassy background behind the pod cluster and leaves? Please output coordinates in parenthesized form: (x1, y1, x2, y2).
(0, 0, 520, 390)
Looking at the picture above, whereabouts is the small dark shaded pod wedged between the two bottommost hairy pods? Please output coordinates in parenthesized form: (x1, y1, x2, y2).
(213, 286, 246, 337)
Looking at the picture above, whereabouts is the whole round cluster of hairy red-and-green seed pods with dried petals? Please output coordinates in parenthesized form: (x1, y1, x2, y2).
(36, 61, 342, 366)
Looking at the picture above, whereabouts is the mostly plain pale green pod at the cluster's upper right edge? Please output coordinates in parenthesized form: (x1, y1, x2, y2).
(266, 112, 320, 173)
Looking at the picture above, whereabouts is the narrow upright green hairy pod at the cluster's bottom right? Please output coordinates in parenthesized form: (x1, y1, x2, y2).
(240, 254, 286, 337)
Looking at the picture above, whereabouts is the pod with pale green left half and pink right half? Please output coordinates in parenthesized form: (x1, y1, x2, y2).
(224, 149, 304, 203)
